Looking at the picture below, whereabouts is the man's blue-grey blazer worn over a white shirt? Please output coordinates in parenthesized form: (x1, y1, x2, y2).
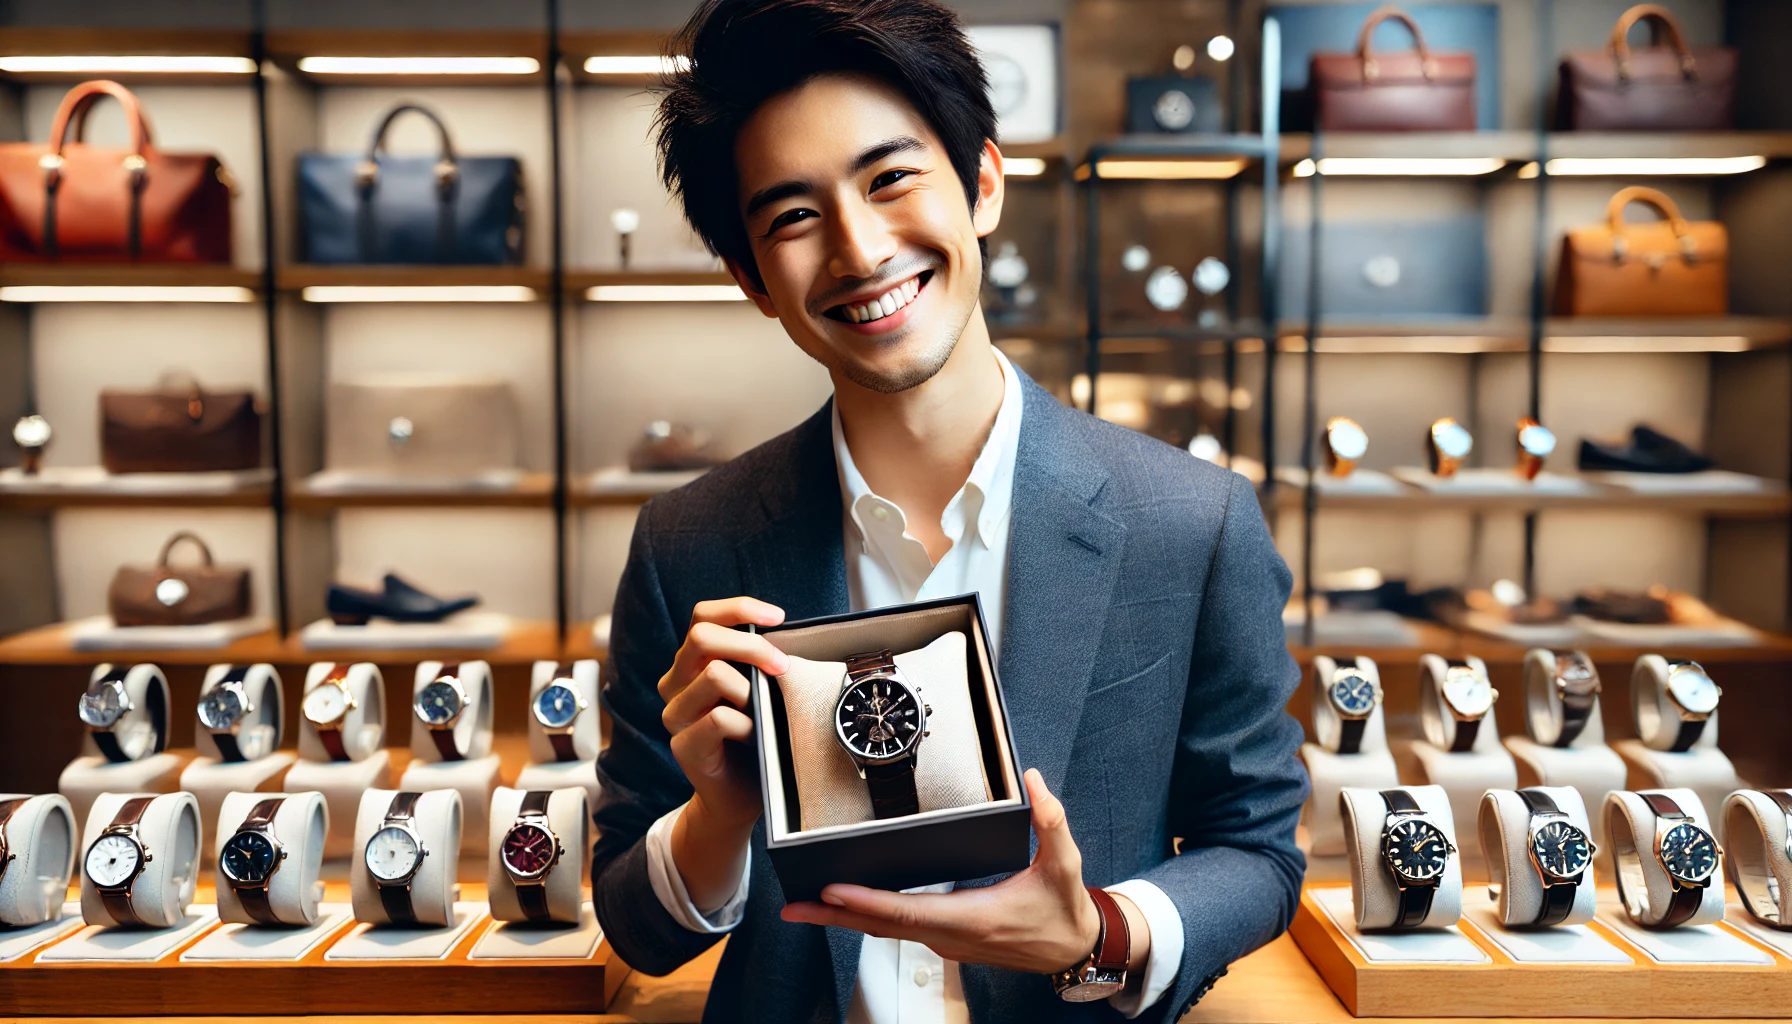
(591, 369, 1306, 1024)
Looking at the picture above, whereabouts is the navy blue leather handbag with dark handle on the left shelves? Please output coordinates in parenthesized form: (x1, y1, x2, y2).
(299, 104, 523, 264)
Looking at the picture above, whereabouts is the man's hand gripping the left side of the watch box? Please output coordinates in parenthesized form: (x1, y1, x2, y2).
(659, 597, 790, 913)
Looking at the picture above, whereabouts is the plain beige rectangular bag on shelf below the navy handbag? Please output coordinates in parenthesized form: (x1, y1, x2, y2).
(324, 375, 518, 479)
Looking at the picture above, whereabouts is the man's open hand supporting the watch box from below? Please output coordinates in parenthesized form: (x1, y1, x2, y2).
(783, 769, 1150, 974)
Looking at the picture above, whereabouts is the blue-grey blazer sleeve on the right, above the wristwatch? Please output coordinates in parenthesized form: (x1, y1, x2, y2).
(1140, 473, 1308, 1022)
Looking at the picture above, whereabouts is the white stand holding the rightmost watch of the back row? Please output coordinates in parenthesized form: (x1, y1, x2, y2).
(1611, 655, 1747, 845)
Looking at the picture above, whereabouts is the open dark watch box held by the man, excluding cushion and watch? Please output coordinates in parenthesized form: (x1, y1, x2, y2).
(749, 594, 1032, 902)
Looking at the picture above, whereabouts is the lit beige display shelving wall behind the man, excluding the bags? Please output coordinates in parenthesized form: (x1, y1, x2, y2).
(0, 0, 1792, 791)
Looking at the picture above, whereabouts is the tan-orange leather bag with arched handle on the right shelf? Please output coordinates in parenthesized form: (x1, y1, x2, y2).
(1555, 185, 1729, 316)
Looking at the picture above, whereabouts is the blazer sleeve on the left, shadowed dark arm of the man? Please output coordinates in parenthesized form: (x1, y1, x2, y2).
(591, 502, 720, 976)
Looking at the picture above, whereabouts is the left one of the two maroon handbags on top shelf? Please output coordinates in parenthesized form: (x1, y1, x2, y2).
(1308, 5, 1475, 131)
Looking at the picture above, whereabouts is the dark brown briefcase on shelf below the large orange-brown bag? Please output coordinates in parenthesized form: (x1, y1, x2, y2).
(100, 375, 262, 473)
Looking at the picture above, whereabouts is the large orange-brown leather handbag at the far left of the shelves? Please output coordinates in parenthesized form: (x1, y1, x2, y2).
(0, 81, 231, 264)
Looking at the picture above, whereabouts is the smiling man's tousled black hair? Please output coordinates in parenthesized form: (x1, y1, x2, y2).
(654, 0, 996, 283)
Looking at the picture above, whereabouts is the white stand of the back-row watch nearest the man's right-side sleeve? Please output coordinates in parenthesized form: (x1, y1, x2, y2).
(1301, 655, 1400, 864)
